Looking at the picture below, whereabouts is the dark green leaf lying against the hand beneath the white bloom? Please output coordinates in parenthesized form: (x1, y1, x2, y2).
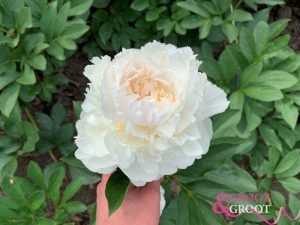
(105, 170, 130, 216)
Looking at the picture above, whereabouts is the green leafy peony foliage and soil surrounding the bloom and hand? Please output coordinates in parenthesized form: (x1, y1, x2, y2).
(0, 0, 300, 225)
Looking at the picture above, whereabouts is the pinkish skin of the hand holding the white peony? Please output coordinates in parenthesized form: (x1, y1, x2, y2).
(96, 175, 161, 225)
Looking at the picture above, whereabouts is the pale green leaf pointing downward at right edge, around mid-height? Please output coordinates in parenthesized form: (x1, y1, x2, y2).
(275, 101, 299, 130)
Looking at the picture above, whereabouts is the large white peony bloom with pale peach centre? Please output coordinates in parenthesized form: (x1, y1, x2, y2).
(75, 41, 229, 186)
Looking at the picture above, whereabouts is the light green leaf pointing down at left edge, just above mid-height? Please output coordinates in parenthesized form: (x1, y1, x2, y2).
(0, 83, 20, 117)
